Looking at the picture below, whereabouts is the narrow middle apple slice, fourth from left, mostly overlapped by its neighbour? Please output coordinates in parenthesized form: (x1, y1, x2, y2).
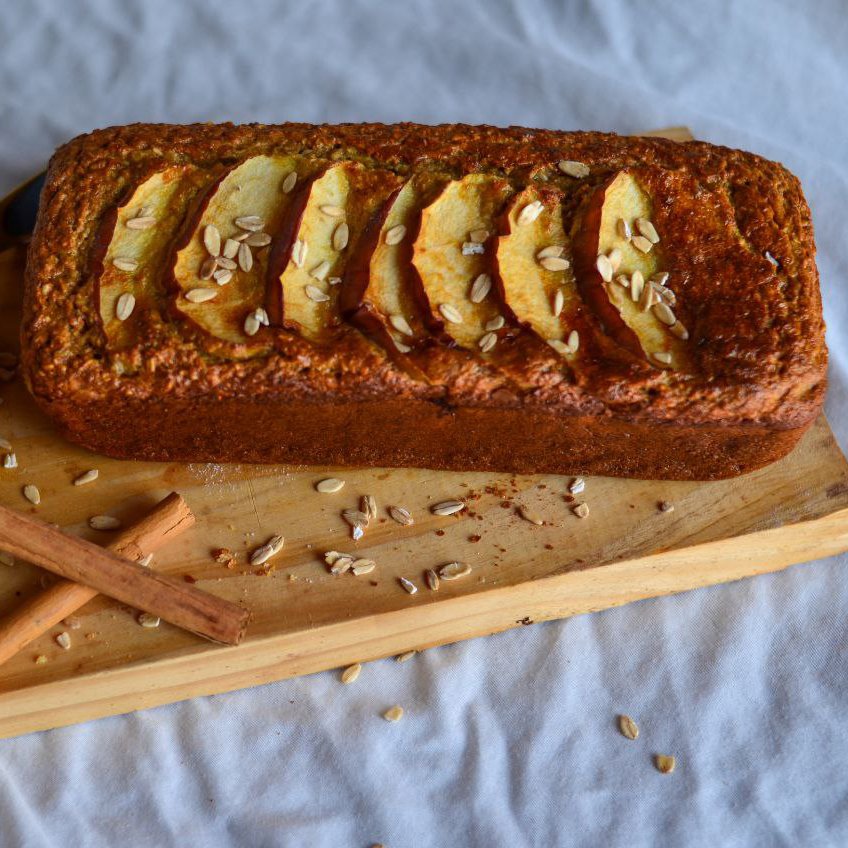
(340, 173, 449, 368)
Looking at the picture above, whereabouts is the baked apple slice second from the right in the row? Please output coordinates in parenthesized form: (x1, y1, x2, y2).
(496, 186, 582, 357)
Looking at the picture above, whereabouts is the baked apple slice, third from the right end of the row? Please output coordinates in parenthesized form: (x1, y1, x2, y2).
(412, 174, 513, 353)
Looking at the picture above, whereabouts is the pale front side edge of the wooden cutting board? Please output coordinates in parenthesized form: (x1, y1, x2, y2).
(0, 509, 848, 738)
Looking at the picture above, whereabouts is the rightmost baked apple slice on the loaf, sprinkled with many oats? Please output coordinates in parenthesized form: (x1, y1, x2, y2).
(574, 170, 689, 370)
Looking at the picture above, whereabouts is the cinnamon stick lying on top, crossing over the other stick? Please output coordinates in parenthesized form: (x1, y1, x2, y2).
(0, 496, 249, 645)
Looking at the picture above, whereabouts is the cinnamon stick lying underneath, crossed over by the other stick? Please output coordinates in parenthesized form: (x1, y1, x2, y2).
(0, 492, 194, 665)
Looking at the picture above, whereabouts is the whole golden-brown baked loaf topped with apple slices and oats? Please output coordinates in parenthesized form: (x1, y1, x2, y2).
(22, 124, 827, 479)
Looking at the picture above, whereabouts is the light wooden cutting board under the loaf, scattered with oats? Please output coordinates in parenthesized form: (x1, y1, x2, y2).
(0, 122, 848, 737)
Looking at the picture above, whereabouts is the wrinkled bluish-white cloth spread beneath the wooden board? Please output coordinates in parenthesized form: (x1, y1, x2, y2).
(0, 0, 848, 848)
